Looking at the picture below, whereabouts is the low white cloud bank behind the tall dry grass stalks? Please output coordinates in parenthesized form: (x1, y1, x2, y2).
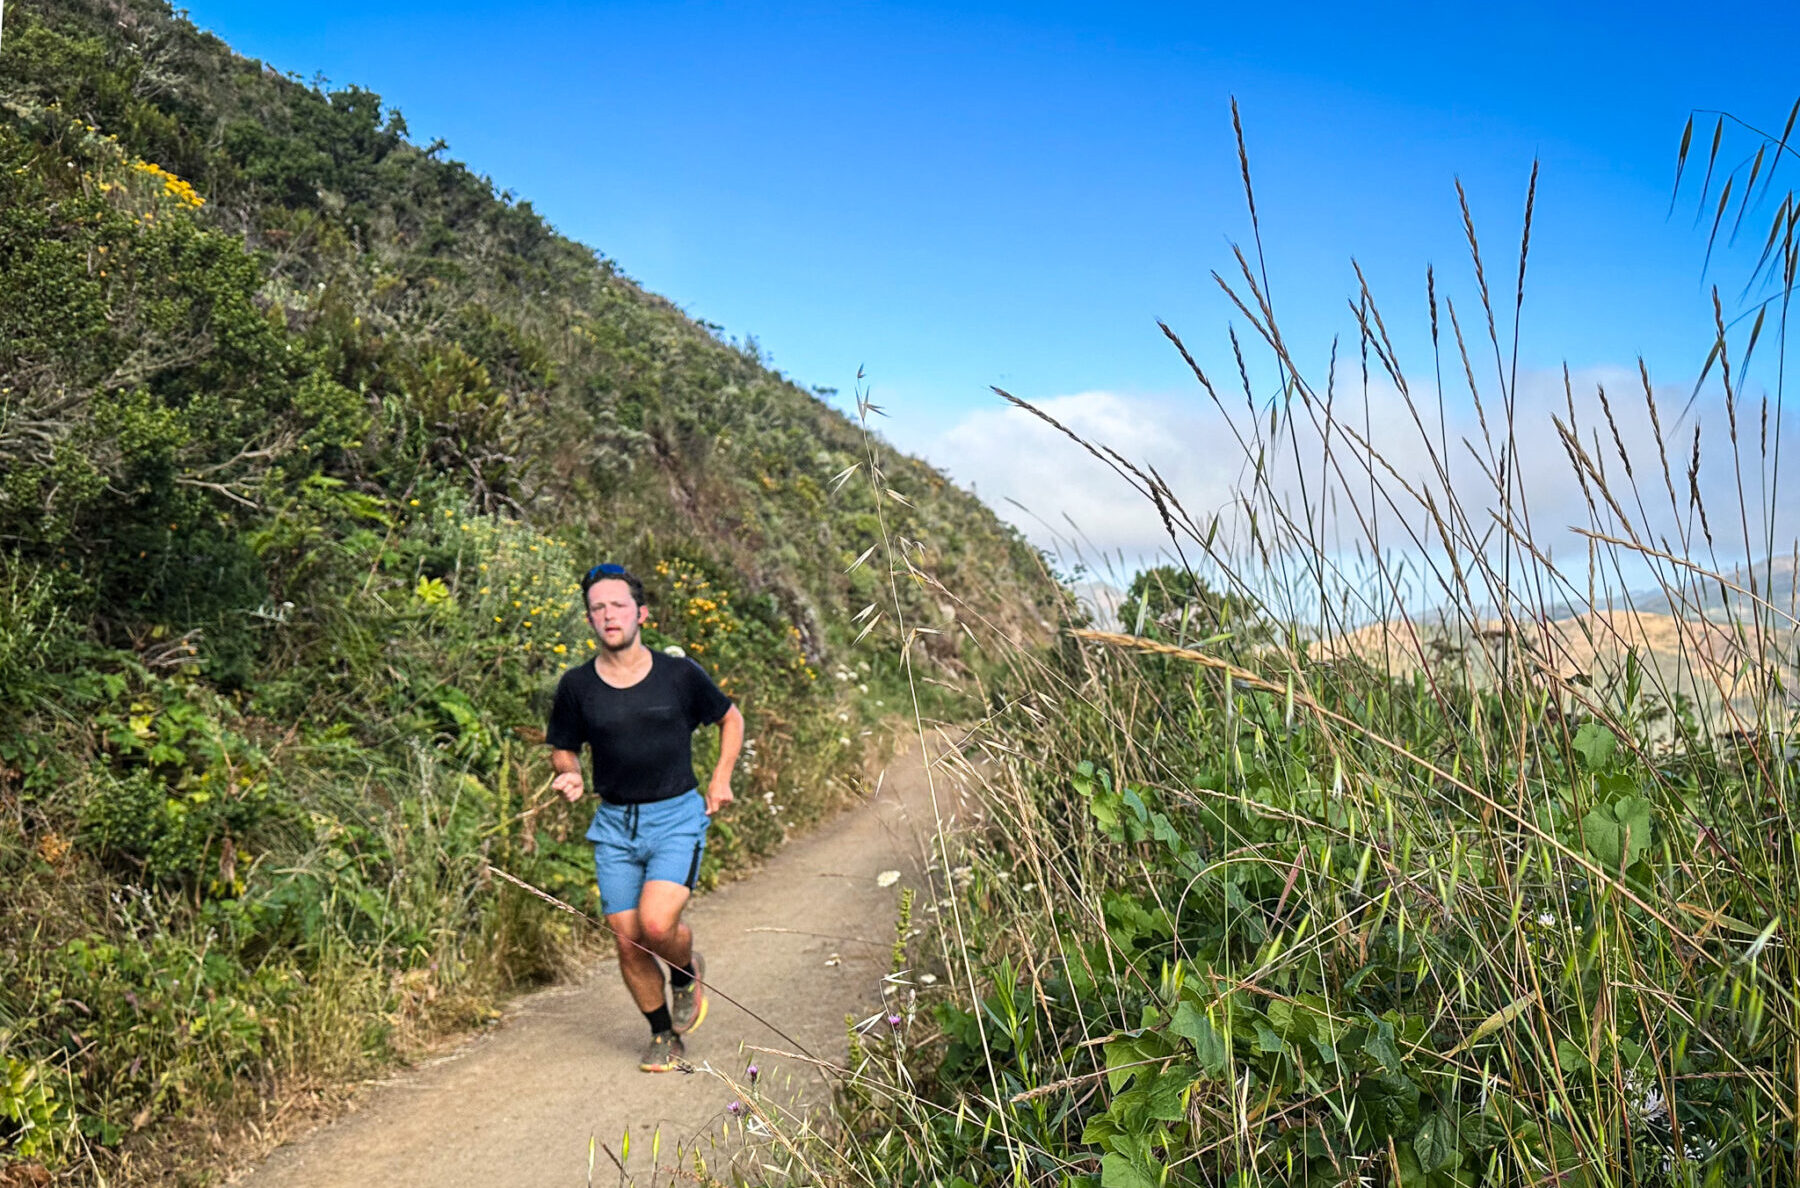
(923, 367, 1800, 601)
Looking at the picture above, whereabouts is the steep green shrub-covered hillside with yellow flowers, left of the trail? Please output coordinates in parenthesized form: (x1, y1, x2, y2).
(0, 0, 1060, 1183)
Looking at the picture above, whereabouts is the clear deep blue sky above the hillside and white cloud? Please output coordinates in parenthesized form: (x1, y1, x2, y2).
(189, 0, 1800, 576)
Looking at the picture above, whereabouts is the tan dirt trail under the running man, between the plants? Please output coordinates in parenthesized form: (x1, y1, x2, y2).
(230, 738, 954, 1188)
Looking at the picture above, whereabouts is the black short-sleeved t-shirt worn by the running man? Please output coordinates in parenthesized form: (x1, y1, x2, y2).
(545, 652, 731, 805)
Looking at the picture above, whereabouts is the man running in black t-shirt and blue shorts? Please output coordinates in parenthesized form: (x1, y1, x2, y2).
(545, 563, 743, 1073)
